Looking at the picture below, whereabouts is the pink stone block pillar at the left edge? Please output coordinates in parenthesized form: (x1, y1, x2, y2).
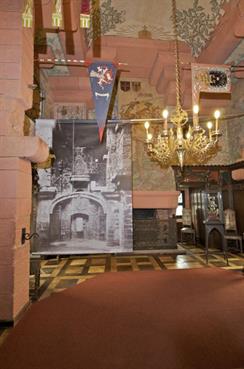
(0, 0, 48, 321)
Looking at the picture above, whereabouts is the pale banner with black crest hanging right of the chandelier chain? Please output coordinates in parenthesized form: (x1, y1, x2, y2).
(191, 63, 231, 105)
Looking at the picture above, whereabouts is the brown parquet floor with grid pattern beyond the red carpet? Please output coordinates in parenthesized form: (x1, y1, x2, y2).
(31, 245, 244, 299)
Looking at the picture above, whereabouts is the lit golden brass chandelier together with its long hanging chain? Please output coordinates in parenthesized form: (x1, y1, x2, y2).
(144, 0, 221, 168)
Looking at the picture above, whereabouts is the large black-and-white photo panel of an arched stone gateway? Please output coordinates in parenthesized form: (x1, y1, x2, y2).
(34, 120, 133, 254)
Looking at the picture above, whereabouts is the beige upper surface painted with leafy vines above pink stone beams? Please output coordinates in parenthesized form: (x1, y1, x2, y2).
(88, 0, 229, 56)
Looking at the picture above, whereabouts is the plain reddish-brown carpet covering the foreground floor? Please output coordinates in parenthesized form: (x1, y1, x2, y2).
(0, 268, 244, 369)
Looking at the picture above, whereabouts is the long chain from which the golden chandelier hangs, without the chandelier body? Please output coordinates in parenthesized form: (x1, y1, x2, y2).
(172, 0, 182, 110)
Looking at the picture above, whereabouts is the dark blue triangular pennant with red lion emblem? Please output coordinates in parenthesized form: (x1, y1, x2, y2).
(88, 62, 117, 142)
